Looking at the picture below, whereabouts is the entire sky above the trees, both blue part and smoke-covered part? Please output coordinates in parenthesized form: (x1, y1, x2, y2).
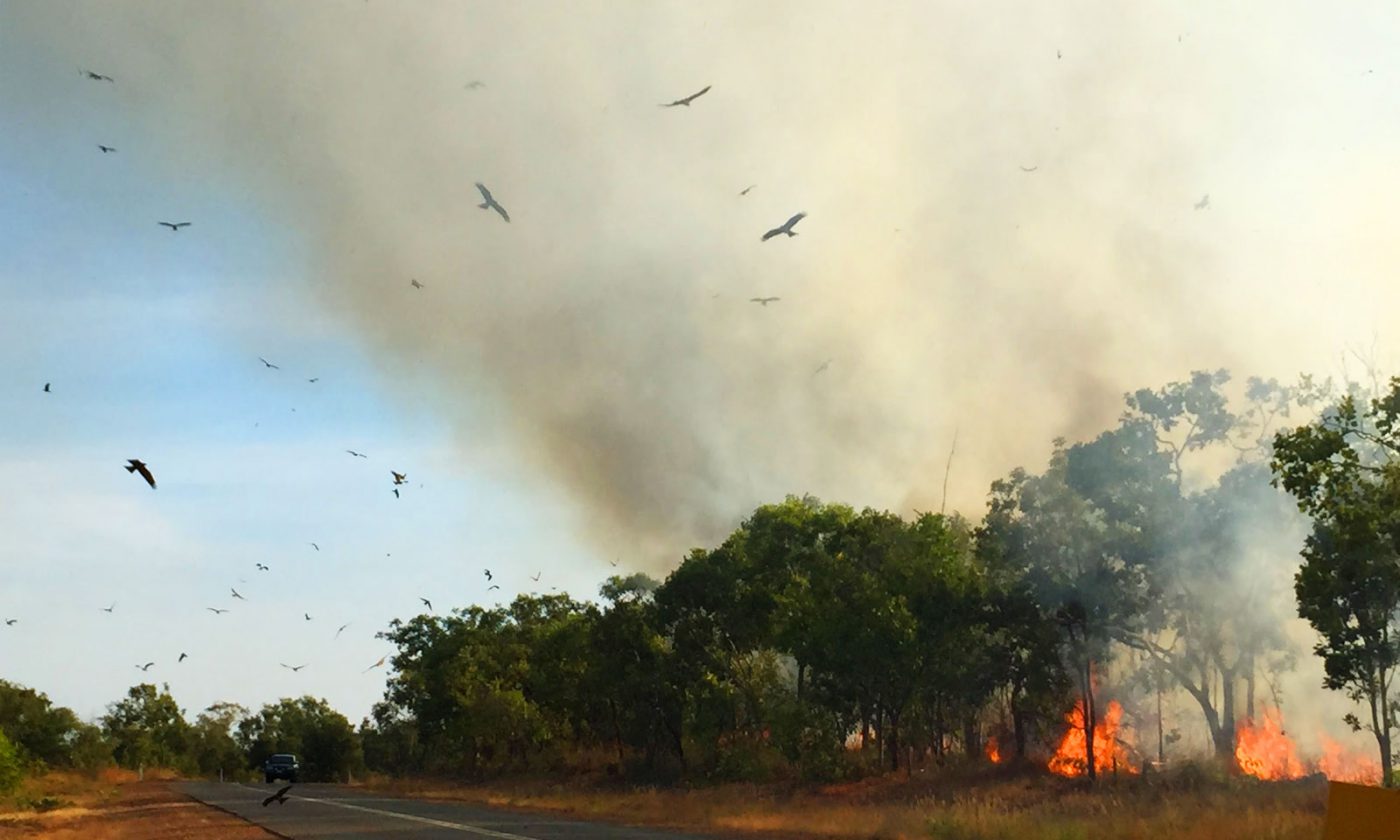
(0, 0, 1400, 721)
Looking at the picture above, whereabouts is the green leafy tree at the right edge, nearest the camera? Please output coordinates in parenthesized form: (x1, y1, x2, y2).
(1273, 378, 1400, 785)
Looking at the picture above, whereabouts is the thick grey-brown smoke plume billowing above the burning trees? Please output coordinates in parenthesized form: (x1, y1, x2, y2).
(10, 0, 1400, 566)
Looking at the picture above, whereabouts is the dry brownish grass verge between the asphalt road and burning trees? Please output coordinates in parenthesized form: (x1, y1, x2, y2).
(371, 771, 1327, 840)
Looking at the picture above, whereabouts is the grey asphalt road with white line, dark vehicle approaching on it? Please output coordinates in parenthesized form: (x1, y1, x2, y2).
(178, 783, 722, 840)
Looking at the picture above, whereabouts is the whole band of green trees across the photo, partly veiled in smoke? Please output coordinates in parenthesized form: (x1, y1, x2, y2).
(10, 371, 1400, 781)
